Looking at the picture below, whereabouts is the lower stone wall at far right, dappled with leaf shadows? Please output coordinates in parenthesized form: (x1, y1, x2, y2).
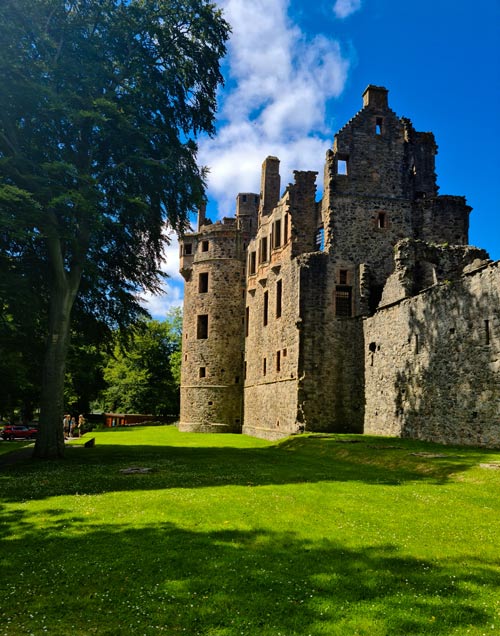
(364, 262, 500, 446)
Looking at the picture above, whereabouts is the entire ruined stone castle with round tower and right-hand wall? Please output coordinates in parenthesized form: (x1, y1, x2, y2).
(179, 86, 500, 446)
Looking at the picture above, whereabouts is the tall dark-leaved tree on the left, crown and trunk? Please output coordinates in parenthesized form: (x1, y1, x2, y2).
(0, 0, 229, 457)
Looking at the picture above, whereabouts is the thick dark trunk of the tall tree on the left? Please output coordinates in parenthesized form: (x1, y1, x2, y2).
(33, 285, 76, 459)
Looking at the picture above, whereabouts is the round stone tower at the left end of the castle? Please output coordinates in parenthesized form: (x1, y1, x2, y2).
(179, 211, 245, 433)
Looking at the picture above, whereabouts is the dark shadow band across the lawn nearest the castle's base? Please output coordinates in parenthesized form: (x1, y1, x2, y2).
(0, 437, 491, 502)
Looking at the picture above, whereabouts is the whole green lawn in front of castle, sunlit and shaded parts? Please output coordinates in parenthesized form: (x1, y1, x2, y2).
(0, 426, 500, 636)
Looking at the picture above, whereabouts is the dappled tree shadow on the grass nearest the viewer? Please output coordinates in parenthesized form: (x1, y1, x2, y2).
(2, 511, 498, 636)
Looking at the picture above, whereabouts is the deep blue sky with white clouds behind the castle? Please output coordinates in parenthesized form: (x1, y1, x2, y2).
(143, 0, 500, 318)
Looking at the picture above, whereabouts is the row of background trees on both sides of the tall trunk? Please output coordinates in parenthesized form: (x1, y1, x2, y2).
(0, 309, 182, 422)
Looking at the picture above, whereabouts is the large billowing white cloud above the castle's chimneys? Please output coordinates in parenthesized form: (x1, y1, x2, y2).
(199, 0, 349, 216)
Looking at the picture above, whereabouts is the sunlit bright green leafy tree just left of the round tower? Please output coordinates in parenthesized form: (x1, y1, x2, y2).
(102, 310, 182, 417)
